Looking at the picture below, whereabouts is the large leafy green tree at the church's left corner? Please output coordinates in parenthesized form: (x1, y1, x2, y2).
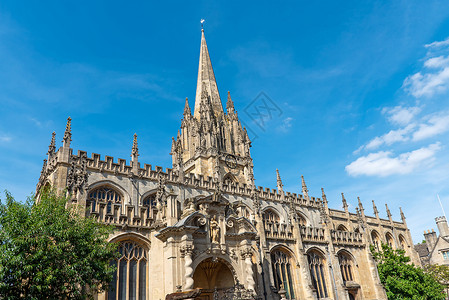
(0, 190, 117, 299)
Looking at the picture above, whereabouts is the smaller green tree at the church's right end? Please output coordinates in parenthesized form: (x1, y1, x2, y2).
(371, 244, 445, 300)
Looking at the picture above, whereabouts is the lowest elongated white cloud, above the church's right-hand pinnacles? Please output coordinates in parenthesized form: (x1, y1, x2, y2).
(345, 142, 441, 177)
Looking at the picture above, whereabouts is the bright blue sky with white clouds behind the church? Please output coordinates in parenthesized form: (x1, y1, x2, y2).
(0, 1, 449, 242)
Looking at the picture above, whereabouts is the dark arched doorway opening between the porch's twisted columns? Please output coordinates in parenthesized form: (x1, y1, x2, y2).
(193, 258, 235, 300)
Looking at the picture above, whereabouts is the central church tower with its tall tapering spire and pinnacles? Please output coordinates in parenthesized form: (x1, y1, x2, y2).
(171, 30, 254, 186)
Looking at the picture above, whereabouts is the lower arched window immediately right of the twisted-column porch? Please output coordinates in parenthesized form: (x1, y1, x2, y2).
(271, 250, 295, 299)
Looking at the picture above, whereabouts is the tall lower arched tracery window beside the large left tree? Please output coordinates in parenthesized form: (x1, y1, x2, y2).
(107, 241, 147, 300)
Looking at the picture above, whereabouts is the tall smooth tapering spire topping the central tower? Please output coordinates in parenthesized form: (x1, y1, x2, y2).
(194, 29, 224, 119)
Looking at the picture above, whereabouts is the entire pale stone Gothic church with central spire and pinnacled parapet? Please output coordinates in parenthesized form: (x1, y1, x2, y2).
(37, 31, 419, 300)
